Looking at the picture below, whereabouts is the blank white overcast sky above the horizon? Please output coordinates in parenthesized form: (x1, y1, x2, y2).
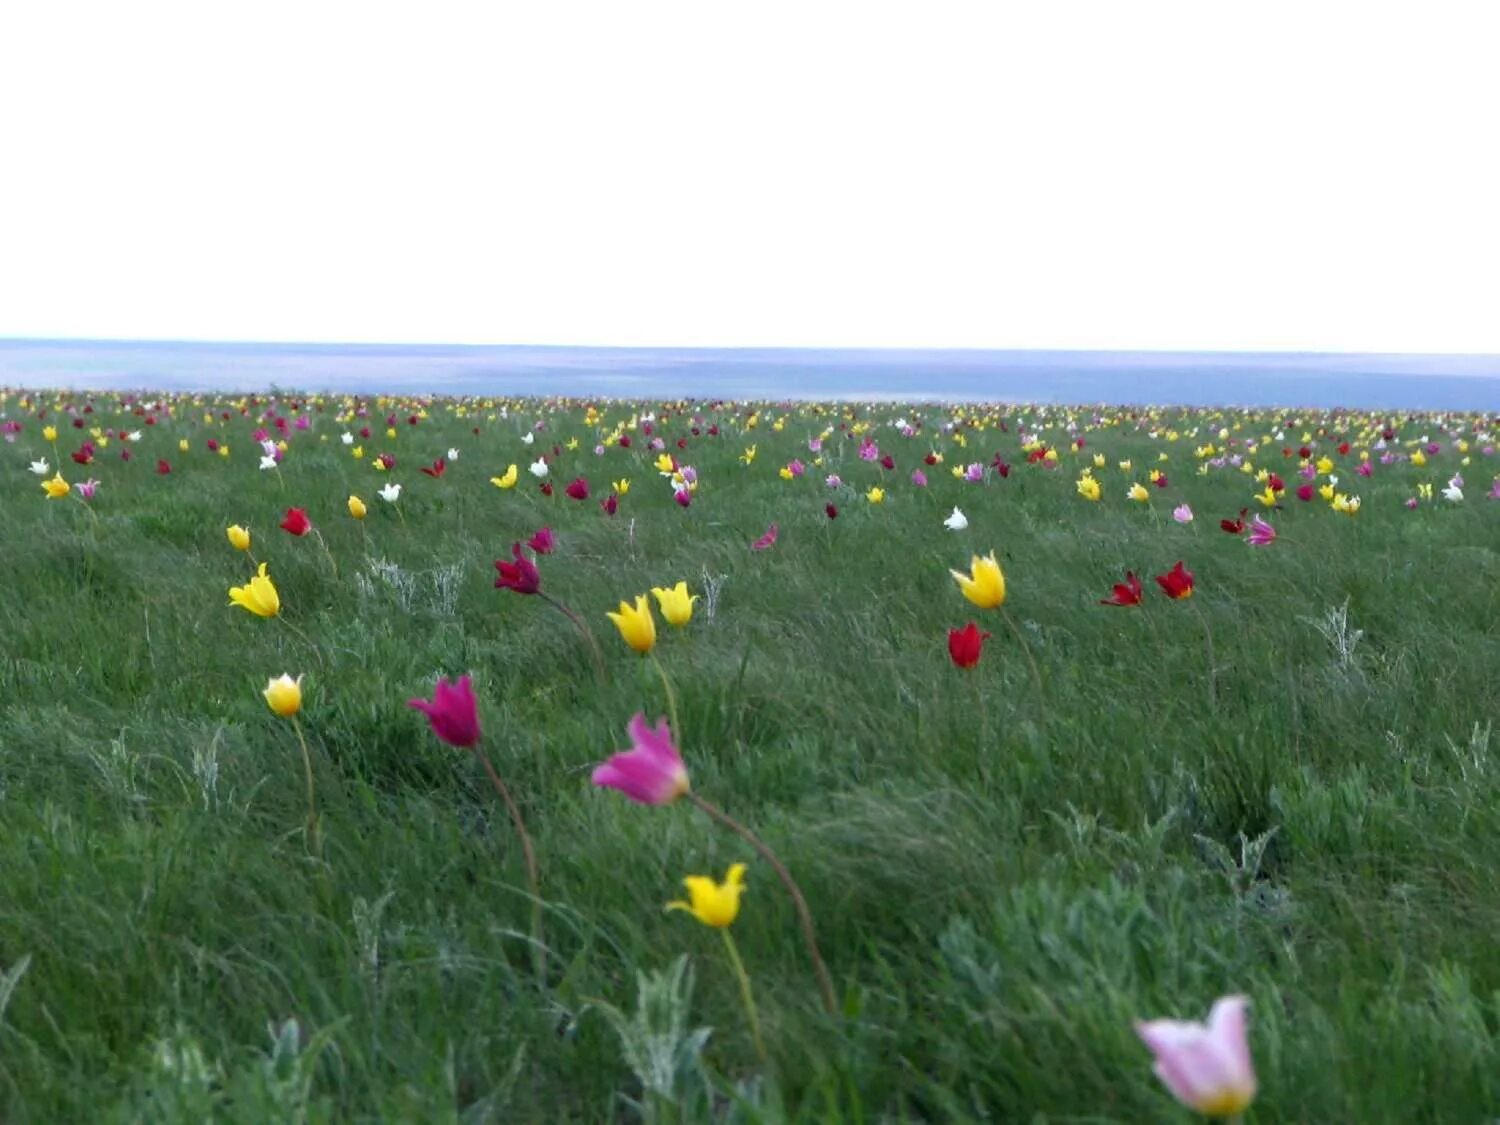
(0, 0, 1500, 353)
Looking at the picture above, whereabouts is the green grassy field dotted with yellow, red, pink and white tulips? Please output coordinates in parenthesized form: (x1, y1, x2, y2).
(0, 390, 1500, 1122)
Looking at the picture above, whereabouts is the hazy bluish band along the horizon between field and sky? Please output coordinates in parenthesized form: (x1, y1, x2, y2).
(0, 339, 1500, 413)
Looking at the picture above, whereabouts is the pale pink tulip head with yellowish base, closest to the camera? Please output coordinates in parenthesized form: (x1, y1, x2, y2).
(1136, 996, 1256, 1118)
